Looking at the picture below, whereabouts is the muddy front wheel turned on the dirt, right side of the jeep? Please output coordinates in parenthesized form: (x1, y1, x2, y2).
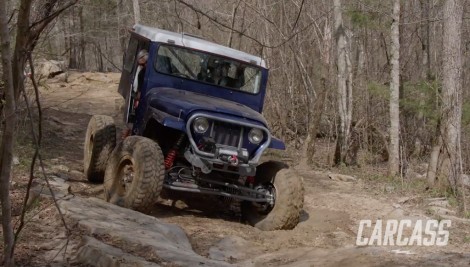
(241, 161, 304, 231)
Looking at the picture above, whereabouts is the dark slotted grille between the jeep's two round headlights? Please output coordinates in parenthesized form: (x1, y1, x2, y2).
(210, 121, 242, 147)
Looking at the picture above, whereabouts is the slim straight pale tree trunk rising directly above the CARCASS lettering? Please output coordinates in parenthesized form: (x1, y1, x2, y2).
(388, 0, 400, 176)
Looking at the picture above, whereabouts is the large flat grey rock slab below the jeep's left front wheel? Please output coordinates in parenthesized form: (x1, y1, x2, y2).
(59, 197, 230, 266)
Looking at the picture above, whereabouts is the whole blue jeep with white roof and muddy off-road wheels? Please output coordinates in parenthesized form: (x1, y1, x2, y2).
(84, 25, 304, 230)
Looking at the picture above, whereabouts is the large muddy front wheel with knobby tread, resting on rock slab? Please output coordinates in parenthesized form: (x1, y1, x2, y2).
(104, 136, 165, 212)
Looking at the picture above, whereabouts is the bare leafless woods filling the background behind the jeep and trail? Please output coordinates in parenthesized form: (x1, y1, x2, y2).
(0, 0, 470, 265)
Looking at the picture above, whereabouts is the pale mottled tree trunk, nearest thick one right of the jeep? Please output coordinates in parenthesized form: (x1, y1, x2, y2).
(333, 0, 352, 165)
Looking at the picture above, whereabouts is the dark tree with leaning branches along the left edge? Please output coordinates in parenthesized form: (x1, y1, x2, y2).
(0, 0, 78, 266)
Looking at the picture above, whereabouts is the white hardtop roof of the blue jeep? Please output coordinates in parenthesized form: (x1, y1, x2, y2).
(134, 24, 266, 68)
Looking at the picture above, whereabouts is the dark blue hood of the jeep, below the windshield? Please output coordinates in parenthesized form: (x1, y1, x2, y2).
(147, 88, 267, 126)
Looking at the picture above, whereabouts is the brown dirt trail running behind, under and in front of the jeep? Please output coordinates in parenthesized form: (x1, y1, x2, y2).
(34, 73, 470, 266)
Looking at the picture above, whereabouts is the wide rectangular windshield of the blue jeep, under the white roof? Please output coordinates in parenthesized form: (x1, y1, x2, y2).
(155, 45, 261, 94)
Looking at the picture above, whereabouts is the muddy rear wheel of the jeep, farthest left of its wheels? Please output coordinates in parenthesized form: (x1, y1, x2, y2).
(83, 115, 116, 183)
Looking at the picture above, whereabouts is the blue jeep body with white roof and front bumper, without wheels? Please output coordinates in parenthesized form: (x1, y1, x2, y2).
(119, 25, 285, 176)
